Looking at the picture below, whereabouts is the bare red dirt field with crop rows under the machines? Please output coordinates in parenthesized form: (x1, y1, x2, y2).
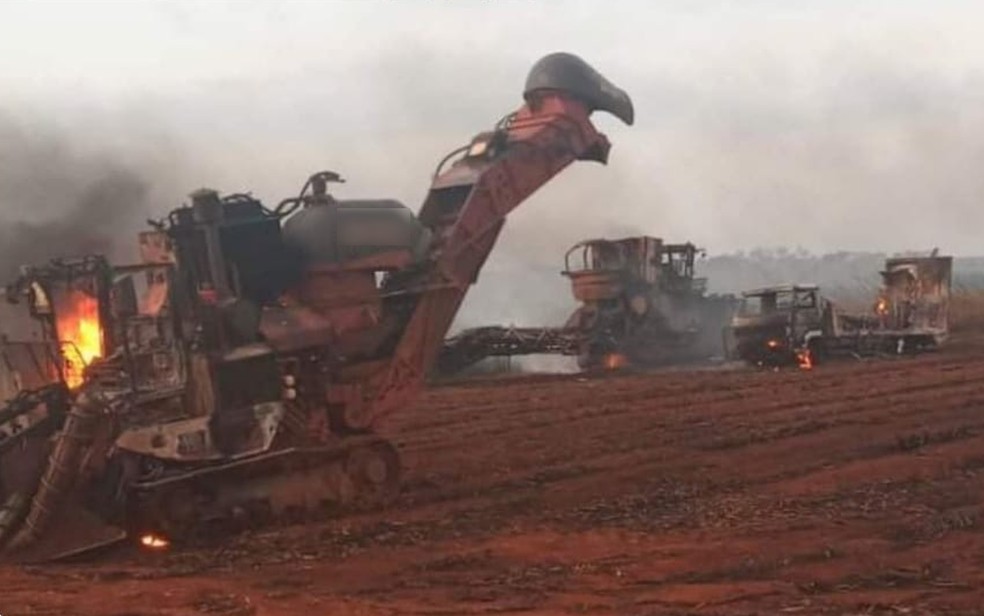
(0, 345, 984, 616)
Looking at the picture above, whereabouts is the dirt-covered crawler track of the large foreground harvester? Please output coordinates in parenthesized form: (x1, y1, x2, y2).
(130, 435, 400, 545)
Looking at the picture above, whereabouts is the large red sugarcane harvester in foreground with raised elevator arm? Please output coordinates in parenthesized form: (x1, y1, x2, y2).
(0, 53, 633, 560)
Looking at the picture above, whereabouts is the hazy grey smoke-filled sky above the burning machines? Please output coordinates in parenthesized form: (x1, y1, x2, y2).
(0, 0, 984, 322)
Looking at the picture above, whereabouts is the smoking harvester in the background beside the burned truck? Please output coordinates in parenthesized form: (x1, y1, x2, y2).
(438, 236, 737, 374)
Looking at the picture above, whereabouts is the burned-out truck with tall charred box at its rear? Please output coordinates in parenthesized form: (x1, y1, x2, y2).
(726, 254, 953, 368)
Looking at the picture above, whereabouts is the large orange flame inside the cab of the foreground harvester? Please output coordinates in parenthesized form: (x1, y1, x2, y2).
(57, 291, 103, 389)
